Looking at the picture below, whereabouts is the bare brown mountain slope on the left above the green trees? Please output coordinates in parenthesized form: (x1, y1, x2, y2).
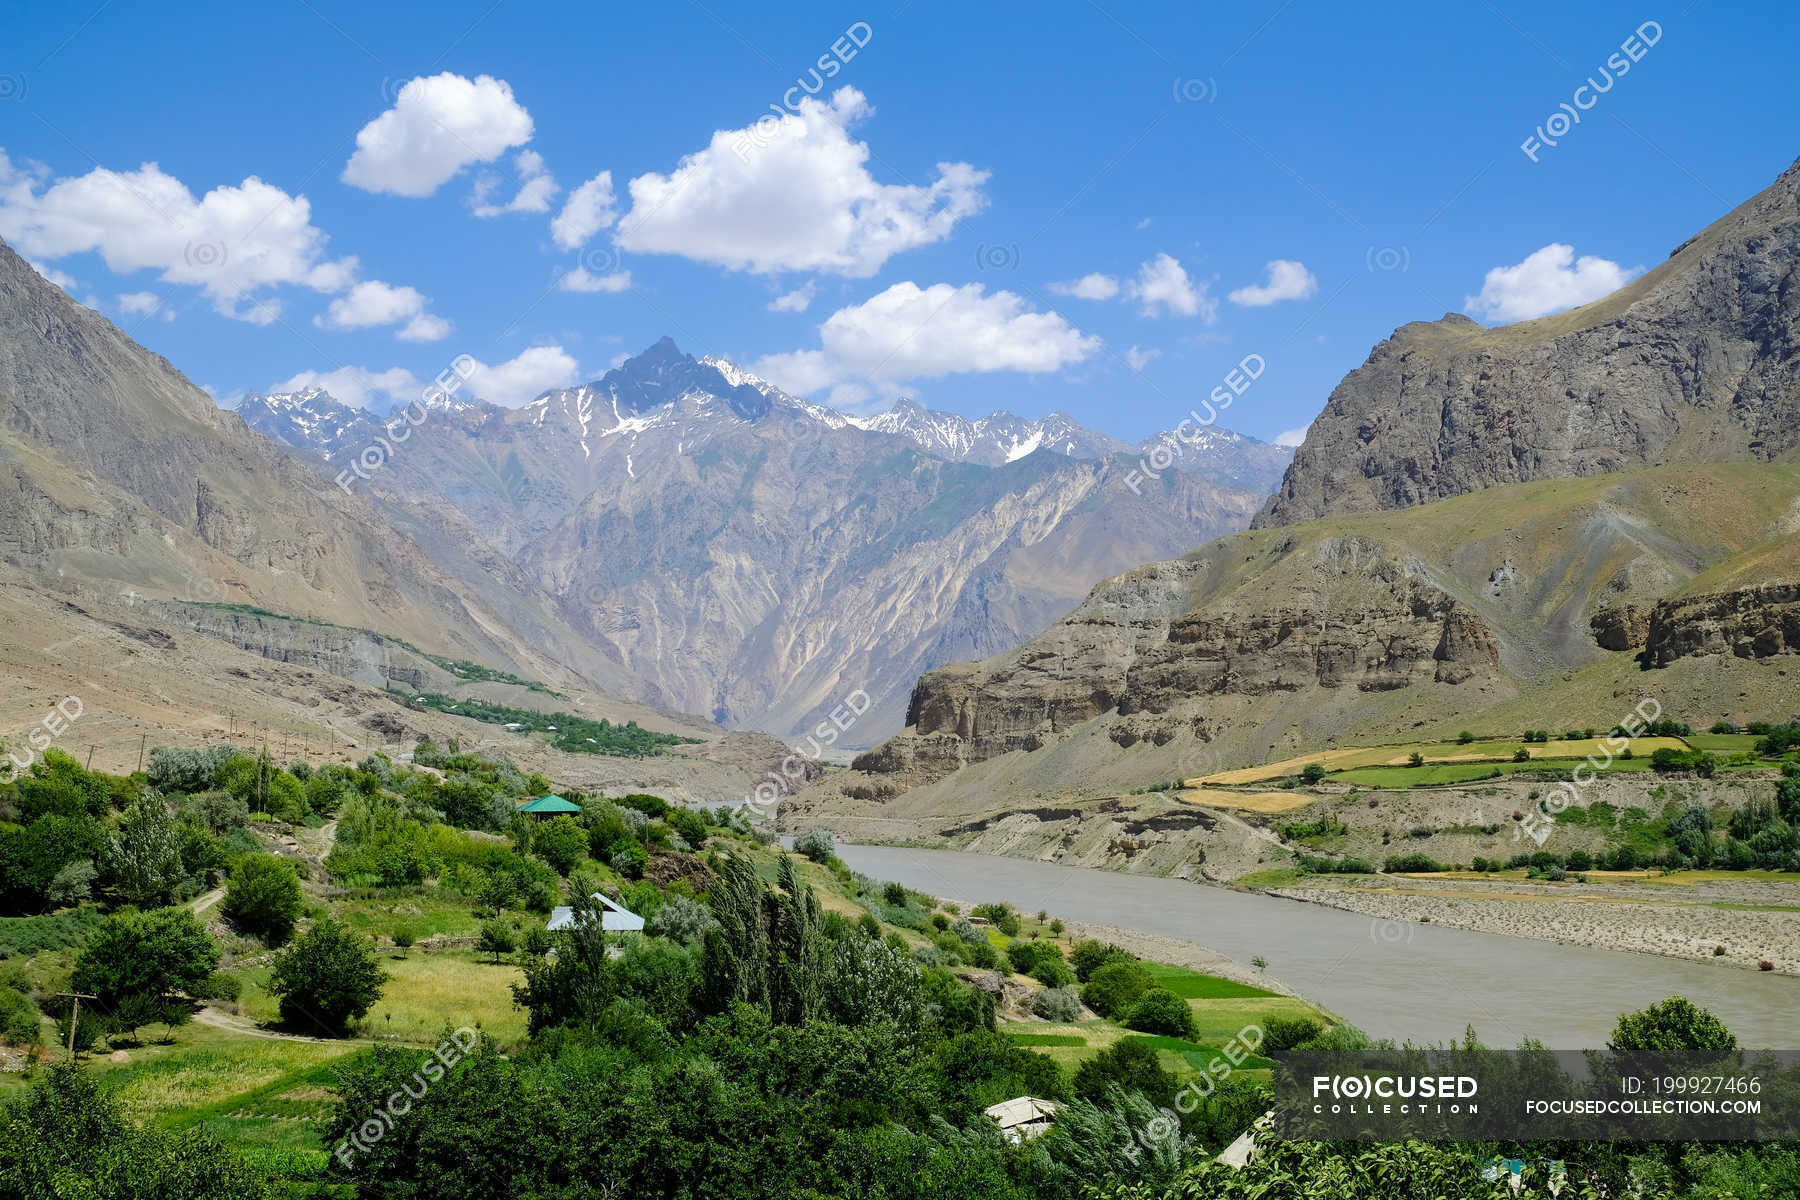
(0, 230, 824, 802)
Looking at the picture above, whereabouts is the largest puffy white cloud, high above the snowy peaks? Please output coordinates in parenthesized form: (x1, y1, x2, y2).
(617, 88, 988, 279)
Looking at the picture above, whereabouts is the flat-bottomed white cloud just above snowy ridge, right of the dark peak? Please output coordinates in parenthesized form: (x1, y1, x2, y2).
(752, 282, 1100, 394)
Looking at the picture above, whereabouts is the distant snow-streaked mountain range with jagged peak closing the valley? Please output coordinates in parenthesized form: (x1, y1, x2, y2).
(239, 338, 1287, 745)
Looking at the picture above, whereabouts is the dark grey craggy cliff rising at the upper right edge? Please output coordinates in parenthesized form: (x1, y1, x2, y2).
(1256, 153, 1800, 527)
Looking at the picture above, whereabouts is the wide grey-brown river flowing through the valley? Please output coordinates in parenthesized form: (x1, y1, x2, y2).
(837, 844, 1800, 1049)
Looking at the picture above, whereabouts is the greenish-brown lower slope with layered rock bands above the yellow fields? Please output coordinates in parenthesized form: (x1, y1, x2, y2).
(785, 464, 1800, 837)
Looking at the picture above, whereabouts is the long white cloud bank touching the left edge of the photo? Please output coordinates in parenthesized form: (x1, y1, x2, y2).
(0, 153, 367, 324)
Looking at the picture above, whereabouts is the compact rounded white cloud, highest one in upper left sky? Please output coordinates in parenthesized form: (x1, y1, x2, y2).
(342, 72, 531, 198)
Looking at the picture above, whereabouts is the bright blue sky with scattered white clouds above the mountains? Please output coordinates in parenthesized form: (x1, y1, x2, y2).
(0, 0, 1800, 447)
